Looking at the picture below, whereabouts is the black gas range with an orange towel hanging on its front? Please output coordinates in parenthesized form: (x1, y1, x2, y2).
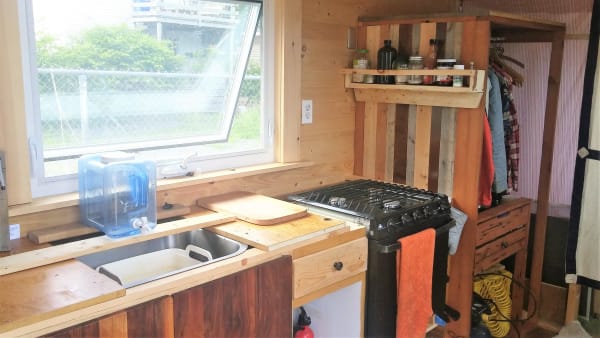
(288, 180, 459, 337)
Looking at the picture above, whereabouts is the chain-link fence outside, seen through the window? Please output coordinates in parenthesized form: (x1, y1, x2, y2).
(38, 69, 260, 155)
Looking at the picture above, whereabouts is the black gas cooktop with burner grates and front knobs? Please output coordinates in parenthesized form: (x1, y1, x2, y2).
(288, 179, 451, 243)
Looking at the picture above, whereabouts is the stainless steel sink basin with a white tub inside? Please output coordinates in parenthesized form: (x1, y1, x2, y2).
(78, 229, 248, 288)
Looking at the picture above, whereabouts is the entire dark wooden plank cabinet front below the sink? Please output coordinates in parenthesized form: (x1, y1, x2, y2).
(44, 256, 292, 338)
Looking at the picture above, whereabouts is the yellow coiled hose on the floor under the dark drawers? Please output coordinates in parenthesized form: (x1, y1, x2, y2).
(473, 269, 512, 338)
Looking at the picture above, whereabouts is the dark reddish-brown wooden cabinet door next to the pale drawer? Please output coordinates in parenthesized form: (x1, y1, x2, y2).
(173, 256, 292, 338)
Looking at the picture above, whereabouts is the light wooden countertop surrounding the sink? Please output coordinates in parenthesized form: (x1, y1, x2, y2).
(0, 213, 364, 337)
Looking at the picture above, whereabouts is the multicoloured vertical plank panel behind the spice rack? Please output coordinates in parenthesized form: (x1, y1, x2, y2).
(354, 23, 462, 194)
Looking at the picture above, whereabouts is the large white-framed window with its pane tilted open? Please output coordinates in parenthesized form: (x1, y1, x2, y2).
(20, 0, 273, 196)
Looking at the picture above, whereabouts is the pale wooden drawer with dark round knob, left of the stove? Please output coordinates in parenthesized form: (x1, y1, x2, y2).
(293, 237, 367, 298)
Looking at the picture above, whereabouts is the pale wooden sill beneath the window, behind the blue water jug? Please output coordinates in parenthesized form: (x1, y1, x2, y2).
(8, 162, 313, 217)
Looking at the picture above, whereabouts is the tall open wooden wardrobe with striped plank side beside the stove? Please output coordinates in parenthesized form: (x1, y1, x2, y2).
(350, 11, 565, 336)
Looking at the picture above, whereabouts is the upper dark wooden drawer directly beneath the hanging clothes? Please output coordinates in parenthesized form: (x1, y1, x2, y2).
(475, 204, 530, 247)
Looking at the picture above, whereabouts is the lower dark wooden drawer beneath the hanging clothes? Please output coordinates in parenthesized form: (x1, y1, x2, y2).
(473, 225, 529, 274)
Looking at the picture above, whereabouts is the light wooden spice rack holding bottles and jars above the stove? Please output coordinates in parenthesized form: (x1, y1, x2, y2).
(341, 69, 485, 108)
